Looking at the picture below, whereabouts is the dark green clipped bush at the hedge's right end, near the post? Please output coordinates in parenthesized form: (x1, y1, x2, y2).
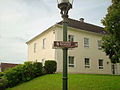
(45, 60, 57, 74)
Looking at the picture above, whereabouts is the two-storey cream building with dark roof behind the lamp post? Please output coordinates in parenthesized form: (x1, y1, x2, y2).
(27, 19, 120, 74)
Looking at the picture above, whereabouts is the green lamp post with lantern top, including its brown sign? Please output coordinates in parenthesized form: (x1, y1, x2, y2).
(54, 0, 74, 90)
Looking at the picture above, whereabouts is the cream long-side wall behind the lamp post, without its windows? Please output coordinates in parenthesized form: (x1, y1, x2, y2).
(56, 26, 112, 74)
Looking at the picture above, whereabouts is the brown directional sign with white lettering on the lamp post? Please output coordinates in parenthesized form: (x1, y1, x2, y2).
(54, 41, 78, 48)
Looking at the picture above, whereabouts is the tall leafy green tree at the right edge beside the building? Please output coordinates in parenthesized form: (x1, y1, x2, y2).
(102, 0, 120, 63)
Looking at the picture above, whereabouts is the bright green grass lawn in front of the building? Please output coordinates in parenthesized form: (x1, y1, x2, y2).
(7, 74, 120, 90)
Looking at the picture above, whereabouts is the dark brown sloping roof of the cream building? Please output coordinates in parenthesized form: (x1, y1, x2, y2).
(57, 18, 107, 34)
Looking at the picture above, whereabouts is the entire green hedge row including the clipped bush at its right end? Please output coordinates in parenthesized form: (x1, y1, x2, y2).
(0, 60, 57, 89)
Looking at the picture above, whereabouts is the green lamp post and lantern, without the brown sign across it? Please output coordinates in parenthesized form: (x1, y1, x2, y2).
(57, 0, 73, 90)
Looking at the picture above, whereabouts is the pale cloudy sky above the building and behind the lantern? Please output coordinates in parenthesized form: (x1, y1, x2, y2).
(0, 0, 111, 64)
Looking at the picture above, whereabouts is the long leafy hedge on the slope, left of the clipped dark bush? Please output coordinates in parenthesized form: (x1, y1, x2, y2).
(4, 62, 42, 87)
